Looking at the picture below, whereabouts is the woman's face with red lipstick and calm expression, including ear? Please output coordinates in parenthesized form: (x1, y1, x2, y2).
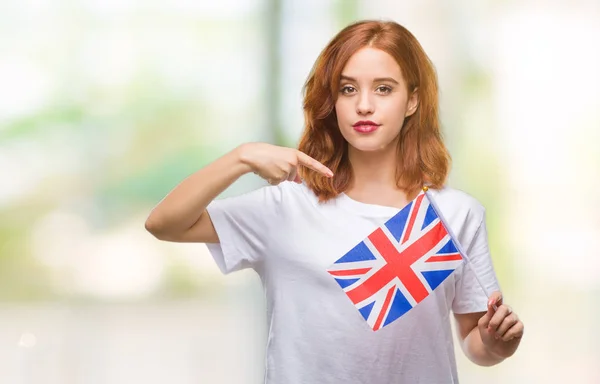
(335, 47, 418, 151)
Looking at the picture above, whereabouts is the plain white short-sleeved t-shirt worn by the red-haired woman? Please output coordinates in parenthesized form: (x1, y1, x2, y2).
(207, 182, 498, 384)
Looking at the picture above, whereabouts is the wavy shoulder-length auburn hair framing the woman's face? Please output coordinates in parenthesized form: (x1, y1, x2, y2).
(298, 20, 450, 201)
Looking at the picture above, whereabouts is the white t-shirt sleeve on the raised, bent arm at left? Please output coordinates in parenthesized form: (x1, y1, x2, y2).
(206, 186, 281, 274)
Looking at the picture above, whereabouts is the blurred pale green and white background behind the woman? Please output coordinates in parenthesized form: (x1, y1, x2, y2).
(0, 0, 600, 384)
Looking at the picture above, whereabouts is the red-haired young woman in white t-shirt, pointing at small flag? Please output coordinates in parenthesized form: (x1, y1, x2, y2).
(146, 21, 523, 384)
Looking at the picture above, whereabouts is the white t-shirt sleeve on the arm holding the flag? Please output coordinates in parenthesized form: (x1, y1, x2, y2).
(452, 212, 500, 313)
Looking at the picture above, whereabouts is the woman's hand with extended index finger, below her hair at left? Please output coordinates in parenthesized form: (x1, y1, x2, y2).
(238, 143, 333, 185)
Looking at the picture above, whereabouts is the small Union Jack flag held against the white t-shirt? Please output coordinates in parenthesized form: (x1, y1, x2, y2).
(327, 192, 463, 331)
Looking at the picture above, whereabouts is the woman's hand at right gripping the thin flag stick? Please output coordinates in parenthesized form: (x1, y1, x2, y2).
(477, 292, 524, 358)
